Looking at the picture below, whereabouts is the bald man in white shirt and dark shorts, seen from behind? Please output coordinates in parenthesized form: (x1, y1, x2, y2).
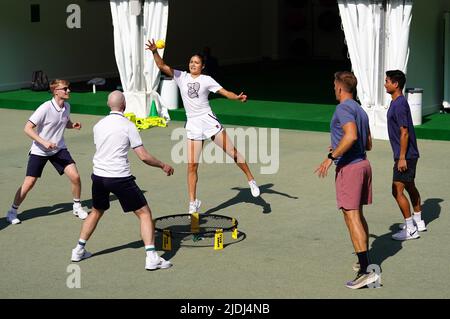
(72, 91, 173, 270)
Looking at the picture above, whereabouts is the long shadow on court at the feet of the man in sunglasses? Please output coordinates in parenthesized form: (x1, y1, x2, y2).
(0, 195, 117, 230)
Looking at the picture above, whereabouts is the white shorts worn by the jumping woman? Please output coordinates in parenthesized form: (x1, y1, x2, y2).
(185, 113, 223, 141)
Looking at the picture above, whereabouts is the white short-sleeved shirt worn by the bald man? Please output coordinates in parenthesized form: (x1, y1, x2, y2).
(93, 111, 143, 177)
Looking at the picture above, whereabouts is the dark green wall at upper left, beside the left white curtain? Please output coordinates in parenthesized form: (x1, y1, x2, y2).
(0, 0, 117, 91)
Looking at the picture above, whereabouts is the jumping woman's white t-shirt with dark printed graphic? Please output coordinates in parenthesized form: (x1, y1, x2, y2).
(173, 70, 222, 118)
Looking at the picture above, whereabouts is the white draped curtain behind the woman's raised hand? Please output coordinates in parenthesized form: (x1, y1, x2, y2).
(110, 0, 169, 119)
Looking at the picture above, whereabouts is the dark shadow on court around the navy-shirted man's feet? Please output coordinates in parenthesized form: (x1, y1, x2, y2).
(369, 198, 443, 268)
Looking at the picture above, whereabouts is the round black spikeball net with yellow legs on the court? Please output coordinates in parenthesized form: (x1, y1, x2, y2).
(154, 213, 244, 251)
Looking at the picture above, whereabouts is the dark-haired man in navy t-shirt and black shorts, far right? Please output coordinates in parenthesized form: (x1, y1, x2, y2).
(384, 70, 426, 240)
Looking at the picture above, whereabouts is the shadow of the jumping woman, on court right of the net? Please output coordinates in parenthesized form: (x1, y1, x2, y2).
(205, 183, 298, 214)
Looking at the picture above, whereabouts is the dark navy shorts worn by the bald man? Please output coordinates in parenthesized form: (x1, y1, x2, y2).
(91, 174, 147, 212)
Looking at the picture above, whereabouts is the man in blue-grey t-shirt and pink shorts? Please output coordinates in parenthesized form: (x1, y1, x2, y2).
(315, 72, 379, 289)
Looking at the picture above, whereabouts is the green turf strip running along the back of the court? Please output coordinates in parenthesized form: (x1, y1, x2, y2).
(0, 84, 450, 141)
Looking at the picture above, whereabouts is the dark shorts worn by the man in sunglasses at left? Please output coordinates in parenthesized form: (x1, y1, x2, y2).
(26, 149, 75, 177)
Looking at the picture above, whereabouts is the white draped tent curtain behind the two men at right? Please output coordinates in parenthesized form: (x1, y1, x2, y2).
(338, 0, 412, 139)
